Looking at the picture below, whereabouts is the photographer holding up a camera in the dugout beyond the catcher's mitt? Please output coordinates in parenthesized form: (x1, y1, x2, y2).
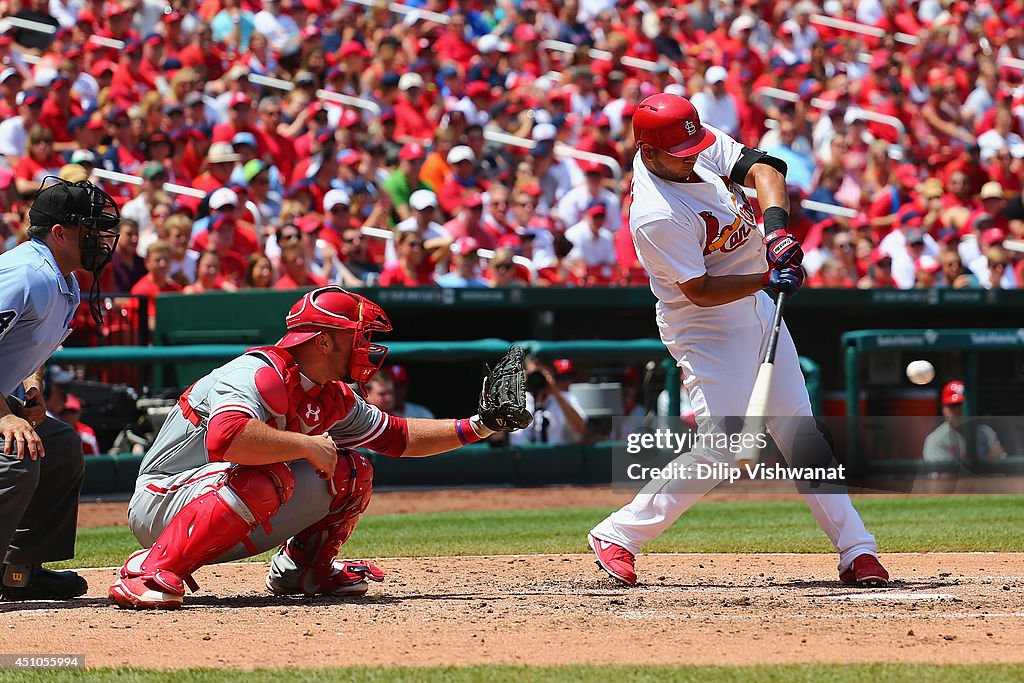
(509, 357, 587, 445)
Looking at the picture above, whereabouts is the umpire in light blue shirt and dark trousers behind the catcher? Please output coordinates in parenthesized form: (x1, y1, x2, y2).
(0, 178, 121, 600)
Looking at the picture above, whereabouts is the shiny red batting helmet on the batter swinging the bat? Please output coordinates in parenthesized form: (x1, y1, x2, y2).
(633, 92, 715, 157)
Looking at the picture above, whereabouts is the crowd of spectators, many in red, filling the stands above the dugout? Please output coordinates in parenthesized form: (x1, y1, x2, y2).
(0, 0, 1024, 317)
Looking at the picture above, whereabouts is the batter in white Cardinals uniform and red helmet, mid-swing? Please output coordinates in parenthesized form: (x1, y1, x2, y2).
(589, 93, 889, 586)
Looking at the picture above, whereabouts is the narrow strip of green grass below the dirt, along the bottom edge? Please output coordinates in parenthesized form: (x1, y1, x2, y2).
(0, 664, 1024, 683)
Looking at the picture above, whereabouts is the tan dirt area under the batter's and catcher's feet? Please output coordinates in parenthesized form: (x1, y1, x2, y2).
(0, 554, 1024, 668)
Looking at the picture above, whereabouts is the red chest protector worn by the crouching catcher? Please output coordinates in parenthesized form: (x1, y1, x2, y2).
(247, 346, 355, 436)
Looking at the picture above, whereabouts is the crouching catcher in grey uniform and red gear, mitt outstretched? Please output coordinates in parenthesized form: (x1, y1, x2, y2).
(110, 287, 532, 608)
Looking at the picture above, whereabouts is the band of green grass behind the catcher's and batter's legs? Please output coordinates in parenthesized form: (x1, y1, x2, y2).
(61, 492, 1024, 567)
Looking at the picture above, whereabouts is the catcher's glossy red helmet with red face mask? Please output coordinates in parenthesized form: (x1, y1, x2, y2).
(276, 285, 391, 389)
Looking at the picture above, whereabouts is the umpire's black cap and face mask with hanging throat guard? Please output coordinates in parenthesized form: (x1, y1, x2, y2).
(29, 175, 121, 325)
